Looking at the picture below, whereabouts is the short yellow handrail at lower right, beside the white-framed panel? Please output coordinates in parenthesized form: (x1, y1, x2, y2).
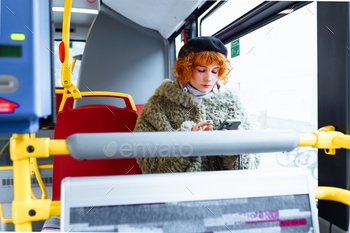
(314, 186, 350, 206)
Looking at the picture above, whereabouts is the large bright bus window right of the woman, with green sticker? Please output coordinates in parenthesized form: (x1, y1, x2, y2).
(202, 1, 318, 186)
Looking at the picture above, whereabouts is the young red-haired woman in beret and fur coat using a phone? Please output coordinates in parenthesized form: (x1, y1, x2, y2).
(135, 37, 260, 173)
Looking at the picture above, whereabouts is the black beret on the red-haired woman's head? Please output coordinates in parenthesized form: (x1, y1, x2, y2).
(178, 36, 227, 58)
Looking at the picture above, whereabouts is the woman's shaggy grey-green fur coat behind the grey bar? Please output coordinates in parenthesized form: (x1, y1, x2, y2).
(134, 79, 260, 174)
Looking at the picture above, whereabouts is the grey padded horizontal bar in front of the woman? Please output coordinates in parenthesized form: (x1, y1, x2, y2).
(67, 130, 299, 160)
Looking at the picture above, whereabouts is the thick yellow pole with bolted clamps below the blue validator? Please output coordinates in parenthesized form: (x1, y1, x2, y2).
(8, 134, 69, 232)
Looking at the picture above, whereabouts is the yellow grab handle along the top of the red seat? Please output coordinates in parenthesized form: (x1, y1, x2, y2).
(62, 91, 137, 111)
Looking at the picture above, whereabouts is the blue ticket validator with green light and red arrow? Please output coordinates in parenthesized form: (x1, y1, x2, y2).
(0, 0, 52, 134)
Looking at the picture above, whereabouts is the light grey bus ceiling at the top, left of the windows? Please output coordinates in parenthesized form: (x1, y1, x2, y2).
(52, 0, 206, 40)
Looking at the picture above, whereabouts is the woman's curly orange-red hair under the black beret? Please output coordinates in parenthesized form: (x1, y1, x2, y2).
(172, 51, 231, 85)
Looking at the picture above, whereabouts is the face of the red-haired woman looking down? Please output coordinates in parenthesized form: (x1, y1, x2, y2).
(189, 62, 220, 93)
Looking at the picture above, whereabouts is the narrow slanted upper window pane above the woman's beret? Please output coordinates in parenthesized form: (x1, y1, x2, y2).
(201, 0, 264, 36)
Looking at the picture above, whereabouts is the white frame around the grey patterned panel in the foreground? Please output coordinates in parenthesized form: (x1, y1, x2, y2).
(61, 168, 319, 232)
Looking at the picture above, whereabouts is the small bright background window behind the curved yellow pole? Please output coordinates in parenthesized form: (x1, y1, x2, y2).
(54, 41, 85, 87)
